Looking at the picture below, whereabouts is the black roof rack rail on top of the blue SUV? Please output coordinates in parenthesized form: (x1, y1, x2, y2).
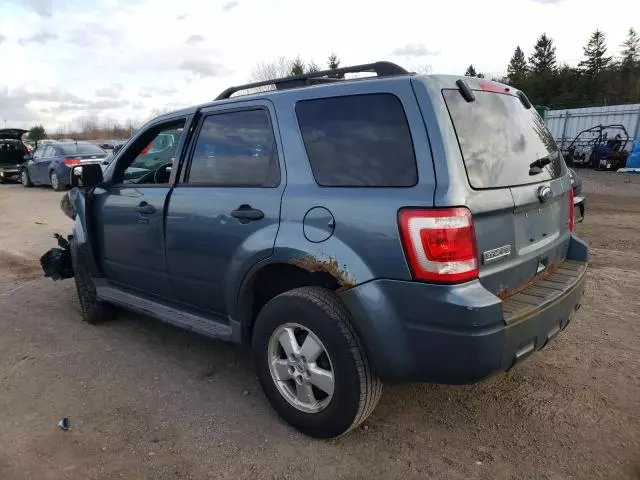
(216, 62, 409, 100)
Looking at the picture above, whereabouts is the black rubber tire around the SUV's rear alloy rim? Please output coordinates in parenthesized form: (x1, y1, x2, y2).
(253, 287, 382, 438)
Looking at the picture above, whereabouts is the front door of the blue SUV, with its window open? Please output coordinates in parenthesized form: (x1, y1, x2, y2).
(94, 118, 187, 297)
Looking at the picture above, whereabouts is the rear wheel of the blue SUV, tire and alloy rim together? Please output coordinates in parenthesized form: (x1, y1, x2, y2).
(253, 287, 382, 438)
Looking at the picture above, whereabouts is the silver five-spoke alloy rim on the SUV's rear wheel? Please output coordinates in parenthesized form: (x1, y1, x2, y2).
(267, 323, 335, 413)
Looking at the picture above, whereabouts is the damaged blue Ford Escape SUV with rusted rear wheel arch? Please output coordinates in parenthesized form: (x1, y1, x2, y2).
(43, 62, 588, 437)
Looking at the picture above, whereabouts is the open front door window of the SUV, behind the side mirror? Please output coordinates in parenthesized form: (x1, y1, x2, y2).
(114, 120, 185, 184)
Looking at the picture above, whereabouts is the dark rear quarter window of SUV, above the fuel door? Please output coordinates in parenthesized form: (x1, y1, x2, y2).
(296, 93, 418, 187)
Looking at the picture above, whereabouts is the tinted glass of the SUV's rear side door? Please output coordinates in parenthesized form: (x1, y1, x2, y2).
(188, 109, 280, 187)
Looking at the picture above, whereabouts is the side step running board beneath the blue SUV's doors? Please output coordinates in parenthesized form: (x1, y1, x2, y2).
(96, 285, 231, 341)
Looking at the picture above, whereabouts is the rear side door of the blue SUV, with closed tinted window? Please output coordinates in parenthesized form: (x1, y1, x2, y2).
(166, 101, 285, 316)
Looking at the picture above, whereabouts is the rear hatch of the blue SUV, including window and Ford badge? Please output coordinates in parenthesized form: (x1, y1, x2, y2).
(442, 81, 573, 299)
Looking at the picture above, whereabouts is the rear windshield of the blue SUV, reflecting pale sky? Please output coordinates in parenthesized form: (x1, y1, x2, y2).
(442, 90, 563, 188)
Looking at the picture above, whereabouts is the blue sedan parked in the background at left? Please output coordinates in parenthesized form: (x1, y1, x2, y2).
(20, 142, 107, 191)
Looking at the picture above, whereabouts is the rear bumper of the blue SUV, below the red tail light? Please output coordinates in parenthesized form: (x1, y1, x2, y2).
(343, 237, 587, 384)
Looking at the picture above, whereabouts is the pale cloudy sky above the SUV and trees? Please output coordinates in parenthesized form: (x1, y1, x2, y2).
(0, 0, 640, 130)
